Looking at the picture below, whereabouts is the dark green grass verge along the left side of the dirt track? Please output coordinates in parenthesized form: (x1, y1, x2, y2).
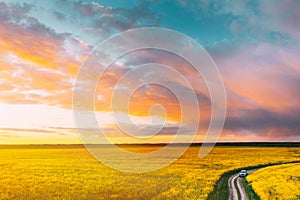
(207, 160, 300, 200)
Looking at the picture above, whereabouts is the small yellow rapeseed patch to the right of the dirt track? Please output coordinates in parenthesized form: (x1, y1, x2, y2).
(247, 163, 300, 200)
